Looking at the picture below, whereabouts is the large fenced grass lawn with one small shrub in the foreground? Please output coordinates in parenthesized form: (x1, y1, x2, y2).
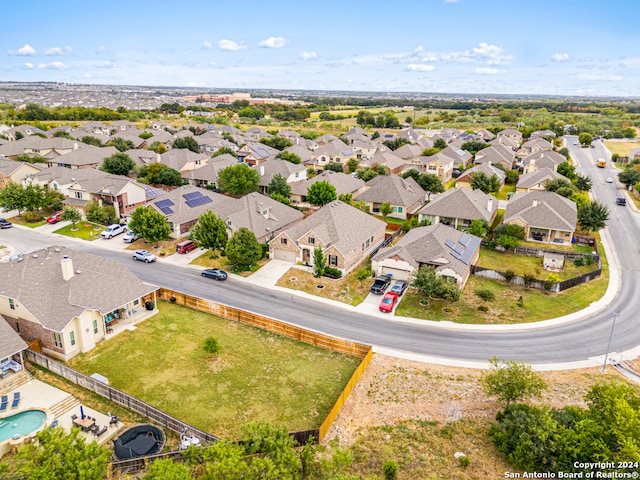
(69, 302, 360, 440)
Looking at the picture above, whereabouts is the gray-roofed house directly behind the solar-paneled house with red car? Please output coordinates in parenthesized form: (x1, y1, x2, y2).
(418, 188, 498, 229)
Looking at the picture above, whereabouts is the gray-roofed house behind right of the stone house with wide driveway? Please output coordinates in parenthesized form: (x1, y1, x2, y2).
(354, 175, 427, 220)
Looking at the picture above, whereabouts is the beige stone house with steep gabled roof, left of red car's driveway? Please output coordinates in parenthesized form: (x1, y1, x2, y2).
(269, 200, 386, 272)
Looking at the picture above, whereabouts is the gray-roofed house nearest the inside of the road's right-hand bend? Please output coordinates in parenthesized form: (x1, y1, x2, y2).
(502, 191, 578, 245)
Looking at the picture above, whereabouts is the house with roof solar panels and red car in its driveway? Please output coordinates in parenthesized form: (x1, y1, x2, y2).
(371, 223, 481, 289)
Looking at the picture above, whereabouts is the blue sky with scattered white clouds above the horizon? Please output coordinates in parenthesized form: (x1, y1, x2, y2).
(0, 0, 640, 96)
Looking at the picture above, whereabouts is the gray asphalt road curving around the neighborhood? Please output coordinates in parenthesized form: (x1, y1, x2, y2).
(2, 141, 640, 369)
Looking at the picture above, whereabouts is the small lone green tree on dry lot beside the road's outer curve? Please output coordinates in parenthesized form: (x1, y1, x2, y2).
(480, 357, 546, 407)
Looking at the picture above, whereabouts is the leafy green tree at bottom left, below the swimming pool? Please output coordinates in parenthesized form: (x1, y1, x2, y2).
(13, 428, 111, 480)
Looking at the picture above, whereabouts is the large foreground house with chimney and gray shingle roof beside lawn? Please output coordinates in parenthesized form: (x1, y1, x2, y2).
(0, 247, 158, 361)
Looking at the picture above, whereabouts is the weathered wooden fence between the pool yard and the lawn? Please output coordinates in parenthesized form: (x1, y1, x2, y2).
(26, 350, 220, 443)
